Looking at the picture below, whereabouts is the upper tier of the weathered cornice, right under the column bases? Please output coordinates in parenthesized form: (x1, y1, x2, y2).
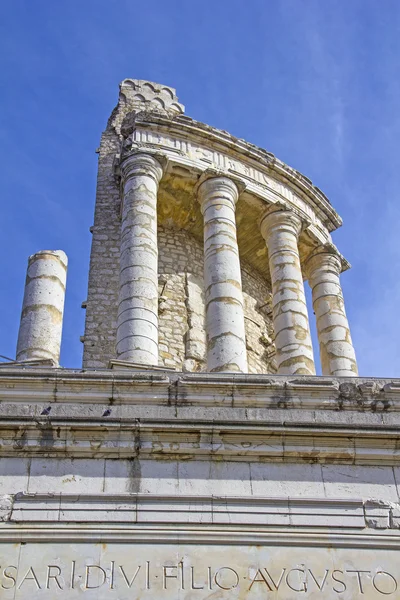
(0, 366, 400, 414)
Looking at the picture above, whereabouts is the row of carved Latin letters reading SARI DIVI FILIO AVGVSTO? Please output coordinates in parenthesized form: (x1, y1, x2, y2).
(0, 560, 400, 598)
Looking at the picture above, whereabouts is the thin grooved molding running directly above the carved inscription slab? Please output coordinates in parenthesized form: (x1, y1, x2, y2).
(0, 523, 400, 550)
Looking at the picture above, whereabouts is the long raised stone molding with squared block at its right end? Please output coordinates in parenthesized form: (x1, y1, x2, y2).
(3, 493, 384, 529)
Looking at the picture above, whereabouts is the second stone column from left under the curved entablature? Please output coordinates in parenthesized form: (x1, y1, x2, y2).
(198, 177, 247, 373)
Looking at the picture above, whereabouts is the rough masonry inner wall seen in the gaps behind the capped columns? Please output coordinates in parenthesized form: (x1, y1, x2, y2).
(158, 227, 276, 373)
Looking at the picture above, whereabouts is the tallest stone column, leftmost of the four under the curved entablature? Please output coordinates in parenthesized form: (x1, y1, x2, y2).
(116, 153, 163, 366)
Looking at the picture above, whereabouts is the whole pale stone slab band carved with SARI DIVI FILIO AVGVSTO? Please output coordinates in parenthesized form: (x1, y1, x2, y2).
(0, 542, 400, 600)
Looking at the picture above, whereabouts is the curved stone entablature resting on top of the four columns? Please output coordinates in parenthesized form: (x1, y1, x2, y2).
(126, 115, 342, 233)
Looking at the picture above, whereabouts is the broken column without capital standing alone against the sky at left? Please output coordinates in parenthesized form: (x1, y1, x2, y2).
(17, 250, 68, 365)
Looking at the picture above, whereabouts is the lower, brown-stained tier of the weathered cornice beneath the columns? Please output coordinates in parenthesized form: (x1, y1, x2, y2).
(0, 418, 400, 466)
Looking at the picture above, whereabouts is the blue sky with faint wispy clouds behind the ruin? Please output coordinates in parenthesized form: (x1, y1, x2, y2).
(0, 0, 400, 377)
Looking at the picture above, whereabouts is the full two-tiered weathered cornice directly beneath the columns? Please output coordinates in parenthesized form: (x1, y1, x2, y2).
(0, 367, 400, 465)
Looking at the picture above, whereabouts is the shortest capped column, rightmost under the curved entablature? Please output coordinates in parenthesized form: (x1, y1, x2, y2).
(305, 248, 358, 377)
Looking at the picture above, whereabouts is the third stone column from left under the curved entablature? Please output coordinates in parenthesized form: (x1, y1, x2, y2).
(261, 206, 315, 375)
